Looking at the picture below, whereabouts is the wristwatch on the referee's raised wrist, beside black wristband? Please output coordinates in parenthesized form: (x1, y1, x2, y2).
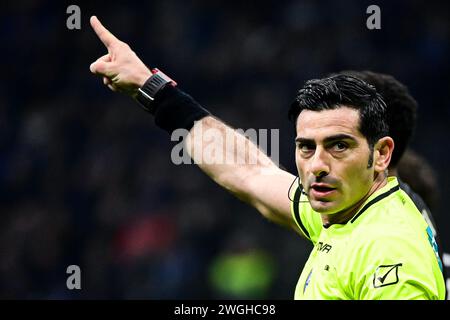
(136, 68, 177, 114)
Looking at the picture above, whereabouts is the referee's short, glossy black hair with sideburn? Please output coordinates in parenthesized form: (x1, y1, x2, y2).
(289, 74, 388, 147)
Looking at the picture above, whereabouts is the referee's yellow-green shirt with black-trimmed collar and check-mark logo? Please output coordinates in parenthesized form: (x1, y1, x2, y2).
(291, 177, 445, 300)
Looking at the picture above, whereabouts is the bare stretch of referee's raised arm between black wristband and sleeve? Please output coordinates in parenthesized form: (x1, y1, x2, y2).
(186, 116, 295, 227)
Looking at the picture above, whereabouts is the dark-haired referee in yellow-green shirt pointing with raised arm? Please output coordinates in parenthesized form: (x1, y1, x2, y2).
(90, 17, 445, 300)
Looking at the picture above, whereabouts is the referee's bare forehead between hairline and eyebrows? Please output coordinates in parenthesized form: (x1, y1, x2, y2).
(296, 107, 364, 140)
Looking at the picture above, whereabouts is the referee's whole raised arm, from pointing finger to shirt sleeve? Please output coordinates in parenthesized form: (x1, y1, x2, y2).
(90, 17, 297, 229)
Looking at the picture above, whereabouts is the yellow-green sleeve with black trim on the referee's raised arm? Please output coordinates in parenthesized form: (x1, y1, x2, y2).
(291, 187, 322, 244)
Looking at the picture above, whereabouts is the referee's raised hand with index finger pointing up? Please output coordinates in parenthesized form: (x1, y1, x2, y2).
(90, 16, 152, 97)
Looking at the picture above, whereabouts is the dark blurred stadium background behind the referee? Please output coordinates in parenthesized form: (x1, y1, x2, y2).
(0, 0, 450, 299)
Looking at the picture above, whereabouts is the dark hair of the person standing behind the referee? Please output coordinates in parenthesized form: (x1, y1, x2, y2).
(330, 70, 417, 167)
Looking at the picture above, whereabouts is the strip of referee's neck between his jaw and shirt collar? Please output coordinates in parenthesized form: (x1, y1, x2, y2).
(321, 173, 387, 228)
